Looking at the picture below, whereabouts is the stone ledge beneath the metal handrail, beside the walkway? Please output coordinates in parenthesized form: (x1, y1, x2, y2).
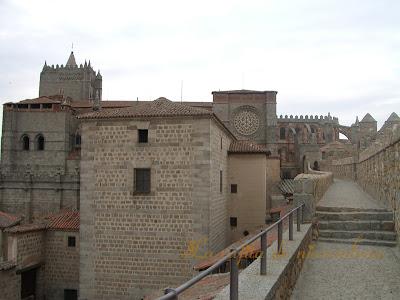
(214, 224, 312, 300)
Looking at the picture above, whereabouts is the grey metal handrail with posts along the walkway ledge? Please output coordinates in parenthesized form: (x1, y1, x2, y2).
(157, 203, 304, 300)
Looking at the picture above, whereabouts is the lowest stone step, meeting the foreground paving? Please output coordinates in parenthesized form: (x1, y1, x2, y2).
(319, 230, 396, 241)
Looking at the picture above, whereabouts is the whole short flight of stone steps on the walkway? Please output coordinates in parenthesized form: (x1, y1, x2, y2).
(316, 206, 396, 247)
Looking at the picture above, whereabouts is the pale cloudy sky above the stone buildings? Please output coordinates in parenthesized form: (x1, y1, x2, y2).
(0, 0, 400, 126)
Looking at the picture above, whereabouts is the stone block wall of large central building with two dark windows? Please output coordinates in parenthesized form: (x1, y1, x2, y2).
(80, 118, 228, 299)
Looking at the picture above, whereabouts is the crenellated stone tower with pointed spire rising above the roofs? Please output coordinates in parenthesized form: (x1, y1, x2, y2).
(39, 52, 102, 101)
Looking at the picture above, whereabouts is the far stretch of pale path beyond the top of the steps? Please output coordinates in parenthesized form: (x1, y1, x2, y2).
(318, 179, 385, 209)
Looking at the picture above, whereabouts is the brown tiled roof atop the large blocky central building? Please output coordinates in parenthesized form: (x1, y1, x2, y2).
(78, 98, 213, 119)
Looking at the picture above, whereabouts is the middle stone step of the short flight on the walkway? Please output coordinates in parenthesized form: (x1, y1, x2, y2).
(318, 220, 394, 231)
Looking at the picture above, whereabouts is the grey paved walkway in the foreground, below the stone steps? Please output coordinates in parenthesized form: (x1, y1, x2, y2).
(291, 242, 400, 300)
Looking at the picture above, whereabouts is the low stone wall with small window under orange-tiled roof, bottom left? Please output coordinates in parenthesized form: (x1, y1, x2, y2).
(45, 231, 79, 300)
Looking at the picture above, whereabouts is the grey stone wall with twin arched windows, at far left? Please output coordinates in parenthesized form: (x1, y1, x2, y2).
(0, 106, 79, 222)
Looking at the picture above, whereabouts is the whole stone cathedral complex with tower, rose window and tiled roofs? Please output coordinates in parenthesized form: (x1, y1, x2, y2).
(0, 53, 398, 300)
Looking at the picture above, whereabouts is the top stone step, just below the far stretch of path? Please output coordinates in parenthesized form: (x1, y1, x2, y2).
(315, 211, 393, 221)
